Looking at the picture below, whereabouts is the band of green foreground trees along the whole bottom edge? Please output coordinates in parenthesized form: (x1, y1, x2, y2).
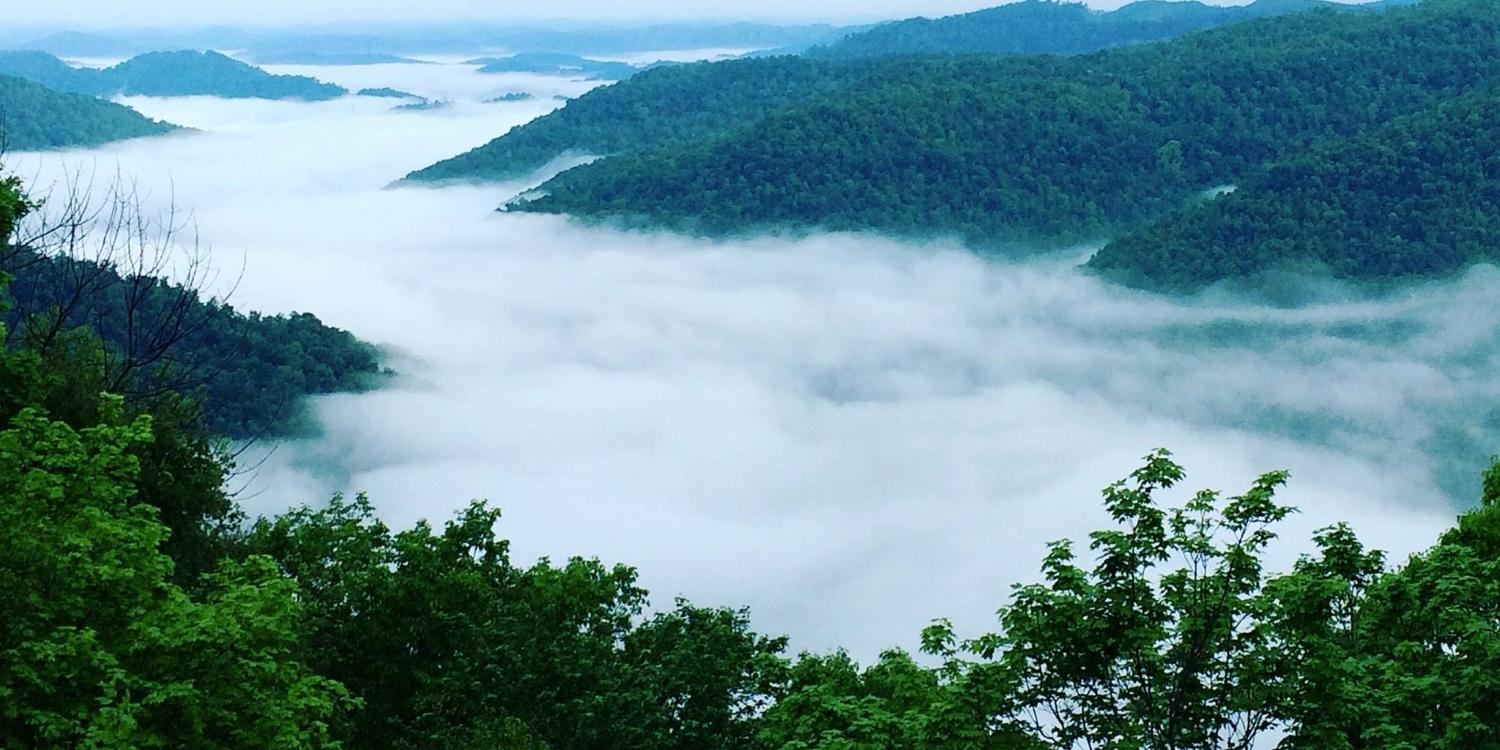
(0, 165, 1500, 750)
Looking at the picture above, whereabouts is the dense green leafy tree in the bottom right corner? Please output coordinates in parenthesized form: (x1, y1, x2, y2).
(1274, 464, 1500, 750)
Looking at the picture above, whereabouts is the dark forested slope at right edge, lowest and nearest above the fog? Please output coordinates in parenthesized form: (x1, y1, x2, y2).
(1089, 87, 1500, 290)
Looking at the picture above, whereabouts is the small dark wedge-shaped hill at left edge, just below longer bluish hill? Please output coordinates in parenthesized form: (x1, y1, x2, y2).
(0, 75, 177, 152)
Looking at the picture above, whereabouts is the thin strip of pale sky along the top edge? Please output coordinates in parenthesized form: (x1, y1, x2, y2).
(3, 0, 1302, 29)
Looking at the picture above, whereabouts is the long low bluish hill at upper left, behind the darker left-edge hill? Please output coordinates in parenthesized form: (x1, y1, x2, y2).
(0, 51, 348, 101)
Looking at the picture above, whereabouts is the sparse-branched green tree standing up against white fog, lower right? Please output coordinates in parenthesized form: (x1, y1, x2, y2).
(926, 452, 1292, 750)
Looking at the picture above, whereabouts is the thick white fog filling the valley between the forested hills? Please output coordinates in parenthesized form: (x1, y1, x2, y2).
(8, 58, 1500, 657)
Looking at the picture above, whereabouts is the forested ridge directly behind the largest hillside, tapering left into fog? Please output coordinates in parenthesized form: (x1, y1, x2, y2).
(407, 57, 887, 182)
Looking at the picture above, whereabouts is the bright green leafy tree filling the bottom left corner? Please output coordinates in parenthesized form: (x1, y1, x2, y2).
(0, 399, 350, 750)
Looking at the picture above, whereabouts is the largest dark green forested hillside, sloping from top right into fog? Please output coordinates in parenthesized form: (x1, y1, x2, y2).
(516, 0, 1500, 245)
